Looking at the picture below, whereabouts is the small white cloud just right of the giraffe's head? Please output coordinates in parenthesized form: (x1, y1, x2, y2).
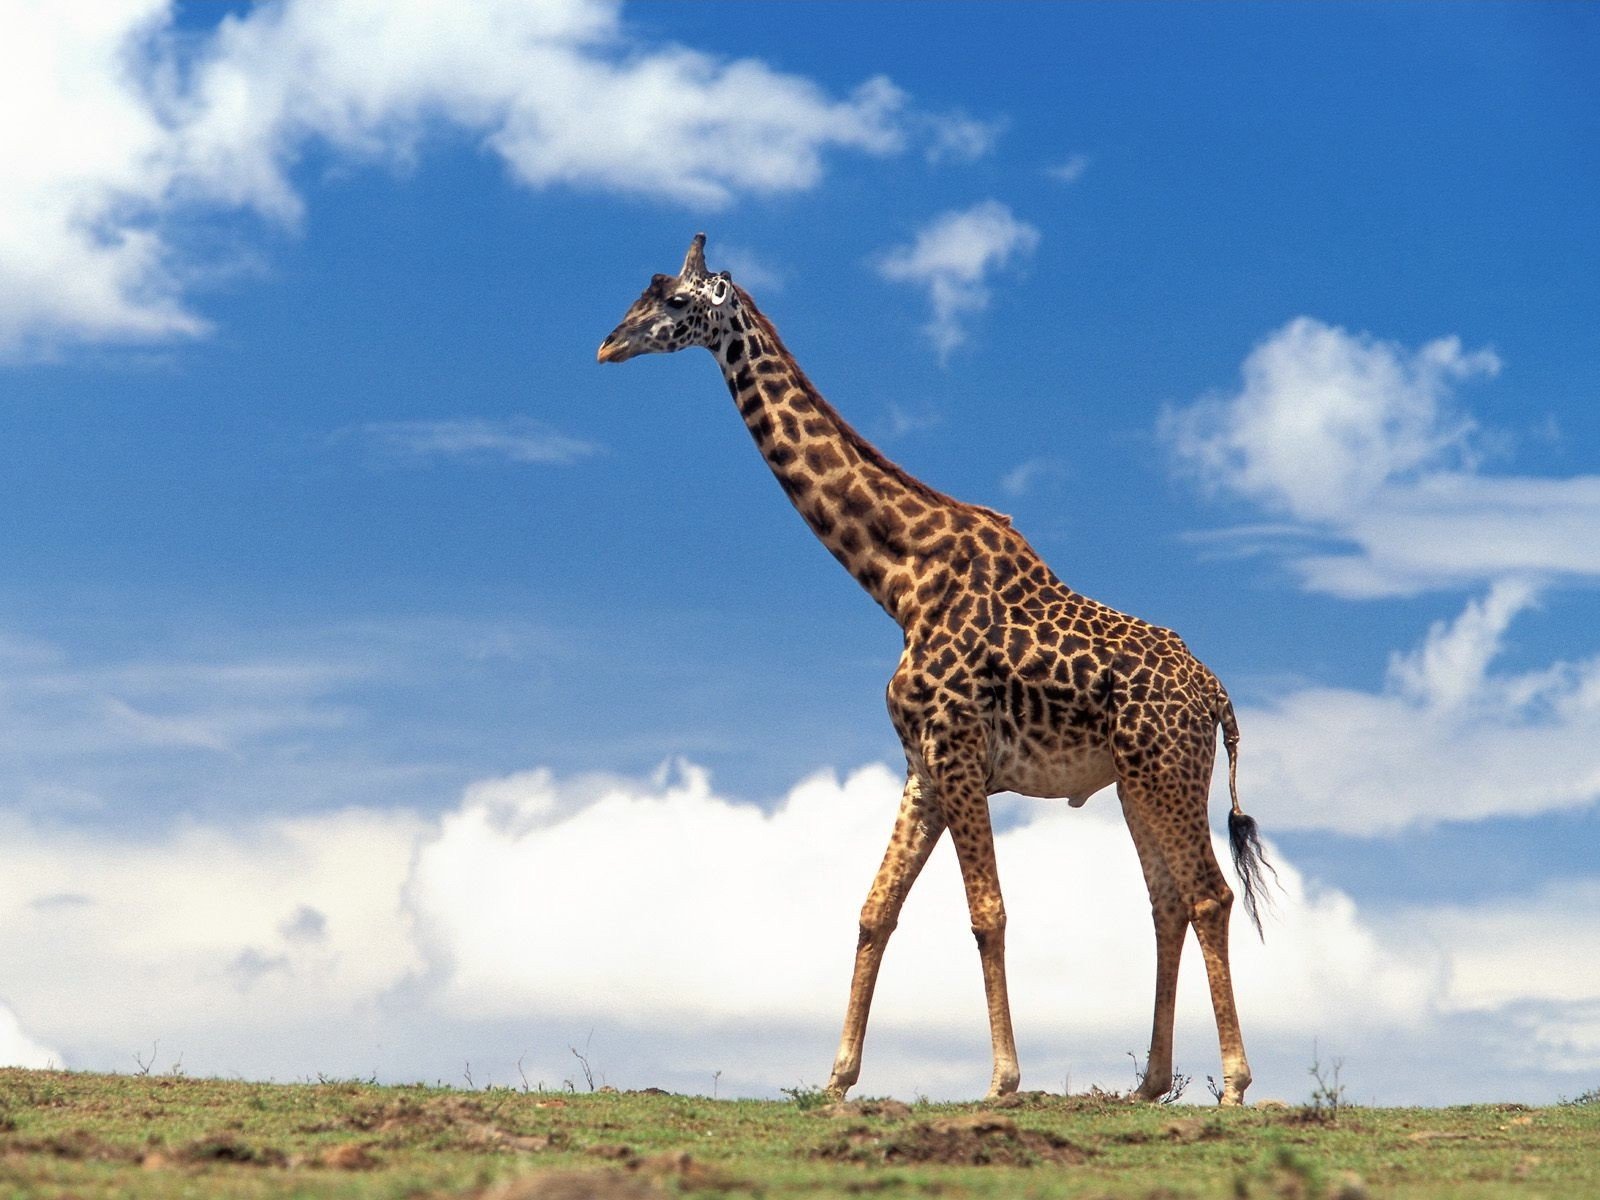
(877, 200, 1040, 362)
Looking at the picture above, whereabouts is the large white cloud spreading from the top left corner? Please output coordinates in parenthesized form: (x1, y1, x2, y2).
(0, 0, 934, 357)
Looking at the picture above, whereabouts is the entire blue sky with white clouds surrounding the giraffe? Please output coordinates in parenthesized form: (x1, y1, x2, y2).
(0, 0, 1600, 1101)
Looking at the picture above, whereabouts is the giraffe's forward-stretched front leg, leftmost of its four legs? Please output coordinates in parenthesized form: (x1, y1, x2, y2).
(827, 776, 944, 1099)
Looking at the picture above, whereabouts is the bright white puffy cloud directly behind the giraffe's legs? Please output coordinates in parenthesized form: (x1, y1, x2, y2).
(410, 766, 1427, 1054)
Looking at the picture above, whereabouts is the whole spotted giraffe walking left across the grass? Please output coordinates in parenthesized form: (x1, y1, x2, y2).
(597, 234, 1270, 1104)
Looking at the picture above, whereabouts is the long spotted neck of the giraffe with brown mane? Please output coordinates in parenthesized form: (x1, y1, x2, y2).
(710, 290, 984, 624)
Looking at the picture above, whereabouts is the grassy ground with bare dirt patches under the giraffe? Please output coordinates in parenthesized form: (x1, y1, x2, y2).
(0, 1070, 1600, 1200)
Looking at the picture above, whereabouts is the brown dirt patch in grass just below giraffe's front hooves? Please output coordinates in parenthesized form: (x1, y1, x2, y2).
(813, 1112, 1093, 1166)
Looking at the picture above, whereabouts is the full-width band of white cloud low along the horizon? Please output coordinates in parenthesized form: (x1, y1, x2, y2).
(0, 766, 1600, 1099)
